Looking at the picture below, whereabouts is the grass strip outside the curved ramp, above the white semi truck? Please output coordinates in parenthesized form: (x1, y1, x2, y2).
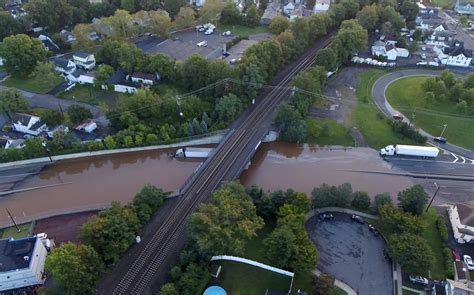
(352, 70, 415, 149)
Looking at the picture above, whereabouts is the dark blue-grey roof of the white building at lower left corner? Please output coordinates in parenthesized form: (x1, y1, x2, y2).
(0, 237, 39, 272)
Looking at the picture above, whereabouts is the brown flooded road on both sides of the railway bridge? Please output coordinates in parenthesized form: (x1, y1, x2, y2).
(0, 143, 413, 226)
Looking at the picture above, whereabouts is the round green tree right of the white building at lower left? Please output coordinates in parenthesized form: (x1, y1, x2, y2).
(45, 242, 104, 294)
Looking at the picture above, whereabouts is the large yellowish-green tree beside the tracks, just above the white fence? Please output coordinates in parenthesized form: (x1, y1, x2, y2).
(188, 183, 263, 255)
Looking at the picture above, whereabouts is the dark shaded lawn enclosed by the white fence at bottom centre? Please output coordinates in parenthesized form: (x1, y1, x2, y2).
(211, 260, 291, 295)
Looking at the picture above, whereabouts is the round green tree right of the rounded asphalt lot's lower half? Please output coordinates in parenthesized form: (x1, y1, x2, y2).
(388, 233, 434, 275)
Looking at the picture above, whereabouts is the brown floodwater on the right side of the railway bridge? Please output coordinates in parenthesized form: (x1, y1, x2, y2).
(241, 143, 413, 200)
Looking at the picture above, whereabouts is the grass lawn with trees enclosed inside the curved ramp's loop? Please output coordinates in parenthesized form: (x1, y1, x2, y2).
(387, 77, 474, 150)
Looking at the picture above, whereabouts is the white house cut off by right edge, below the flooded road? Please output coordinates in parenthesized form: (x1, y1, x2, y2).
(448, 204, 474, 244)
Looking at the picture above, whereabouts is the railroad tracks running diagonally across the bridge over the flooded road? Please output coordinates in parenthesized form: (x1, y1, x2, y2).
(108, 36, 331, 294)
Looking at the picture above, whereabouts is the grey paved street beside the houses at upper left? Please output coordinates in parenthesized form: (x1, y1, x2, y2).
(0, 85, 109, 126)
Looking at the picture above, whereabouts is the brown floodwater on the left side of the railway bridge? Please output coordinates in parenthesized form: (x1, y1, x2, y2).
(0, 150, 200, 225)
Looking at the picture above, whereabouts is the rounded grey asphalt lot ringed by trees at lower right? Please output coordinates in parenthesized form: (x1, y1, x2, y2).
(306, 213, 393, 295)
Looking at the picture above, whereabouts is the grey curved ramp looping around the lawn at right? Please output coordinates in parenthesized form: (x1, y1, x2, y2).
(372, 69, 474, 159)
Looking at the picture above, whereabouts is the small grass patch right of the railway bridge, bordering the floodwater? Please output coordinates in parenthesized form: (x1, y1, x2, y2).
(306, 118, 354, 146)
